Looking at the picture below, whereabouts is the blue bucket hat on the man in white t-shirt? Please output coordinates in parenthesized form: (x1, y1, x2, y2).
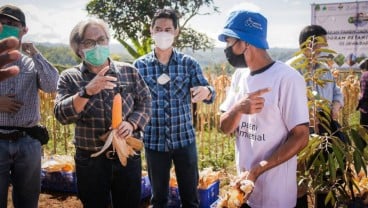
(218, 10, 269, 49)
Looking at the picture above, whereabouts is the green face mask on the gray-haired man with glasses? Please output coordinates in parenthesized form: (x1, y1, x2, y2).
(83, 45, 110, 66)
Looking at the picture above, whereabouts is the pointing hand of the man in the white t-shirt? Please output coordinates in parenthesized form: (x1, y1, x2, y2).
(236, 88, 271, 114)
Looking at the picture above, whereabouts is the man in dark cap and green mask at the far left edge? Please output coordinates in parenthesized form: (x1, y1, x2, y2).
(0, 5, 59, 208)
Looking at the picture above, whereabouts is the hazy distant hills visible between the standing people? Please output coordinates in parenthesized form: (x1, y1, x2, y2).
(36, 43, 298, 67)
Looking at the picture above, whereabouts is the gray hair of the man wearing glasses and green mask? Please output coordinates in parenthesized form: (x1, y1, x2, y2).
(69, 18, 110, 58)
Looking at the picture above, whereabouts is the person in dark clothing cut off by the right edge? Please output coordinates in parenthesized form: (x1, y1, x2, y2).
(358, 58, 368, 129)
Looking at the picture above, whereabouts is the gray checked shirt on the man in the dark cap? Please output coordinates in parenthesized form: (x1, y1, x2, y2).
(0, 53, 59, 128)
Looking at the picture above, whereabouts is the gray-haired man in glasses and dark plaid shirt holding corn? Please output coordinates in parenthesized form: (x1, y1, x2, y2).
(54, 19, 151, 208)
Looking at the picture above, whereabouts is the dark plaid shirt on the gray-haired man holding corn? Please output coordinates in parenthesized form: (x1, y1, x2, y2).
(54, 61, 151, 151)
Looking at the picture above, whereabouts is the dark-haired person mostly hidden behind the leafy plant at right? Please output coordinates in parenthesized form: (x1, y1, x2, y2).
(286, 25, 346, 208)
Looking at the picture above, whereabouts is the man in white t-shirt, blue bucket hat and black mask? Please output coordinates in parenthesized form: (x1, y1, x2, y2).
(219, 11, 309, 208)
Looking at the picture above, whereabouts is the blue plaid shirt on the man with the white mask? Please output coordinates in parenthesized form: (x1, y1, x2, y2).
(134, 49, 215, 152)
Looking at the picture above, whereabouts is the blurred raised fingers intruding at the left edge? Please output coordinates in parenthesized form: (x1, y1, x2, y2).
(0, 36, 21, 81)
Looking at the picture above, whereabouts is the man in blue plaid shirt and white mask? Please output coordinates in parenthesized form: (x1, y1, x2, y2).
(134, 9, 215, 207)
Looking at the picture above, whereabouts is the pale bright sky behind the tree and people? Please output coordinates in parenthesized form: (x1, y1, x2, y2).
(0, 0, 362, 48)
